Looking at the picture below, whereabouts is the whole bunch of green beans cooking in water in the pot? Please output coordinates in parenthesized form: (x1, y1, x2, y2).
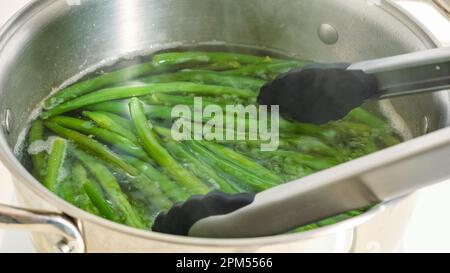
(28, 52, 401, 231)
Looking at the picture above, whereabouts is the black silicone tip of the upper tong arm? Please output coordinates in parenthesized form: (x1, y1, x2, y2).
(258, 64, 379, 125)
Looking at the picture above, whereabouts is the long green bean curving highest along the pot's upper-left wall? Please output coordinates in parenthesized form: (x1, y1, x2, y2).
(44, 63, 170, 110)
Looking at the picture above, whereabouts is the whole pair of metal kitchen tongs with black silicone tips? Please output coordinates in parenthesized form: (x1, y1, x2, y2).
(153, 48, 450, 238)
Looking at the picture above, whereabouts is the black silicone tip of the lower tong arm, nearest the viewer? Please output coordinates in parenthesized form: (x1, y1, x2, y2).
(152, 191, 255, 236)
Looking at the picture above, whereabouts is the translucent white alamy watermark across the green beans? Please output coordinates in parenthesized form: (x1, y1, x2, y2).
(171, 97, 280, 151)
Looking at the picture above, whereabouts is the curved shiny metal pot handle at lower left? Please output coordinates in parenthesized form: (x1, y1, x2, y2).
(0, 204, 85, 253)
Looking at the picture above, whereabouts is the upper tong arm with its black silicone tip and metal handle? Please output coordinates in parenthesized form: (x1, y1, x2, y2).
(258, 48, 450, 124)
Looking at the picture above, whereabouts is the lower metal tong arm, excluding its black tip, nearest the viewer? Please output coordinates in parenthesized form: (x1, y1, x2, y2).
(189, 128, 450, 238)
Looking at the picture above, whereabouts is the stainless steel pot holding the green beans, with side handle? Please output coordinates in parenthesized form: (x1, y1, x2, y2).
(0, 0, 449, 252)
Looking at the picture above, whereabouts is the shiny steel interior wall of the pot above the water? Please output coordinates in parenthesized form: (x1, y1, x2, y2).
(0, 0, 448, 150)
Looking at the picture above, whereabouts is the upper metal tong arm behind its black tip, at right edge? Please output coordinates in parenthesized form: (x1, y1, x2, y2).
(348, 47, 450, 99)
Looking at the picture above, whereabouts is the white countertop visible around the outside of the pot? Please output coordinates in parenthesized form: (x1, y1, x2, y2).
(0, 0, 450, 253)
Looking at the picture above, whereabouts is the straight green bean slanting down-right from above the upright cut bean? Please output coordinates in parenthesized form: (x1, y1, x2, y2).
(45, 121, 140, 176)
